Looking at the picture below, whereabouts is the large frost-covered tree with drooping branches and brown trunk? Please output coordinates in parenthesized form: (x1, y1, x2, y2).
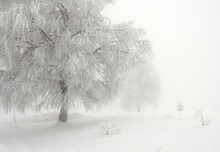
(0, 0, 149, 122)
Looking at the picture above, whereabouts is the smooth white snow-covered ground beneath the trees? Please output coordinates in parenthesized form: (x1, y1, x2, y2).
(0, 111, 220, 152)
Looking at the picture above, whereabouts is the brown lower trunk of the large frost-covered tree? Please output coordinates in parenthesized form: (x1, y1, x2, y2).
(58, 80, 68, 122)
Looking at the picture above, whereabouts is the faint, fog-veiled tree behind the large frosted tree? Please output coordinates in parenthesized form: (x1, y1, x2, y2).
(120, 64, 160, 112)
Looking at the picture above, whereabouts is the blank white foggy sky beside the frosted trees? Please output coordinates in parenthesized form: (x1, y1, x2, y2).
(104, 0, 220, 108)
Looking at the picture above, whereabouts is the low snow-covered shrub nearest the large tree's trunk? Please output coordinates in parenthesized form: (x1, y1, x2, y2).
(100, 124, 121, 136)
